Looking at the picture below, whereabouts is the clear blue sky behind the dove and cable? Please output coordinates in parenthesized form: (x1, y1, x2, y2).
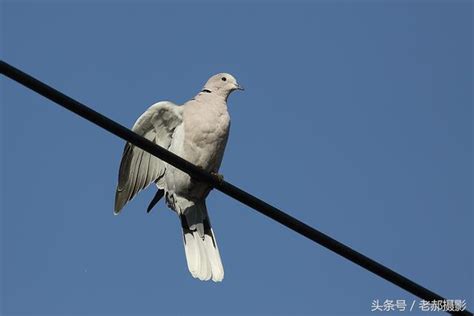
(0, 0, 474, 315)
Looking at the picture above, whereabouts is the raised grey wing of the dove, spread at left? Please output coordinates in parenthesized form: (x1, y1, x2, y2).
(114, 101, 183, 214)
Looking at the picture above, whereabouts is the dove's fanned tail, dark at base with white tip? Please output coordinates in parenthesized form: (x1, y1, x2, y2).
(180, 201, 224, 282)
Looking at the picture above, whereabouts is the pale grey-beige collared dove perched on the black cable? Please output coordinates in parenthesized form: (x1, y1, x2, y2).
(114, 73, 243, 282)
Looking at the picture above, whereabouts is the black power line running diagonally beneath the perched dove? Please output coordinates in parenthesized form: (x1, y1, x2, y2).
(0, 61, 472, 315)
